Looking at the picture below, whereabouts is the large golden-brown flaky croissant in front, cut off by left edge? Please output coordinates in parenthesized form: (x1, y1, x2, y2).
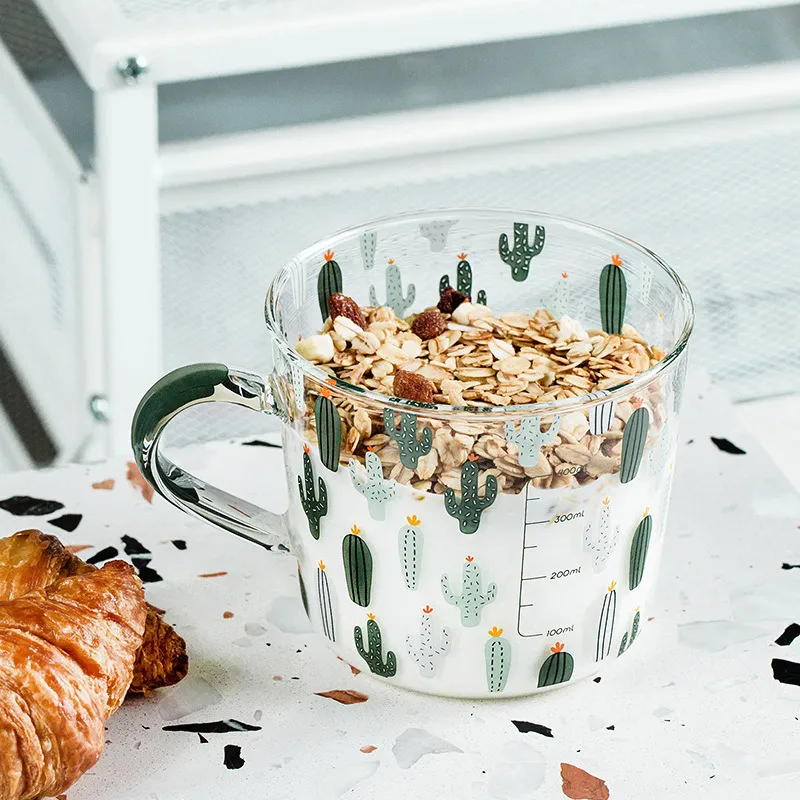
(0, 561, 147, 800)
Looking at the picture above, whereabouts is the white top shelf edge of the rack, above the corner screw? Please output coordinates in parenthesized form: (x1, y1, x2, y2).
(37, 0, 793, 89)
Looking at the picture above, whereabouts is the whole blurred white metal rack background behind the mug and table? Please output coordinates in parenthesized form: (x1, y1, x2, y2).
(0, 0, 800, 480)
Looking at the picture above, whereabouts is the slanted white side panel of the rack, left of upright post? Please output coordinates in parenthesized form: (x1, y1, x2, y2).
(0, 36, 85, 462)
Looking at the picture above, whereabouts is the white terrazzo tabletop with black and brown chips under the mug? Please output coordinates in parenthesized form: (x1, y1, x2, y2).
(0, 372, 800, 800)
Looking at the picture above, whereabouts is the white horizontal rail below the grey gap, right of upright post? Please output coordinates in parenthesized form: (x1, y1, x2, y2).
(160, 61, 800, 213)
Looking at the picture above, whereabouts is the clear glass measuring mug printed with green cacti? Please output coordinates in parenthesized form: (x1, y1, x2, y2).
(132, 210, 693, 697)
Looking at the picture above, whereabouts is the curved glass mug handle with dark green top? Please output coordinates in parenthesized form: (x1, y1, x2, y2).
(131, 364, 289, 550)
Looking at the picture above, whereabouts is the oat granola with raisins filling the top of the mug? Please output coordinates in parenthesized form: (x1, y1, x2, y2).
(296, 296, 666, 494)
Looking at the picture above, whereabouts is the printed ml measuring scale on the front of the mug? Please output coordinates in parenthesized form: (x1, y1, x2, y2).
(517, 482, 585, 637)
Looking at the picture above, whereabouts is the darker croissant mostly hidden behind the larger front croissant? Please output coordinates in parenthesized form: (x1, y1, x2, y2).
(0, 530, 189, 692)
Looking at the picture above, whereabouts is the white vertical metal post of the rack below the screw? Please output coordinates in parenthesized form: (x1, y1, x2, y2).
(95, 80, 162, 453)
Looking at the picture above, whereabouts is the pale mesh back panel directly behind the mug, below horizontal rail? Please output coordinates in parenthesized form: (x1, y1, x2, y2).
(162, 121, 800, 444)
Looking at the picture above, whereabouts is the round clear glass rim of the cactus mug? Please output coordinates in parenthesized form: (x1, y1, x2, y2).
(264, 206, 695, 421)
